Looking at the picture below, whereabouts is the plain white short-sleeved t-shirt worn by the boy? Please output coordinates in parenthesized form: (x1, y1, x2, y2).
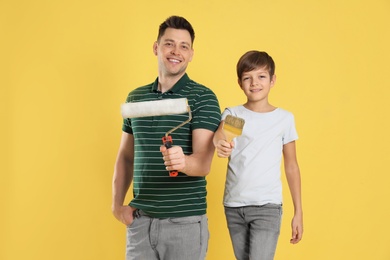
(222, 105, 298, 207)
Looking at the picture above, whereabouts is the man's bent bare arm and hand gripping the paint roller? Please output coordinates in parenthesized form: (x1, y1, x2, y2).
(160, 129, 214, 176)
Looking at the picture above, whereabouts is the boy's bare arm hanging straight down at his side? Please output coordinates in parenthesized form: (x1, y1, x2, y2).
(283, 141, 303, 244)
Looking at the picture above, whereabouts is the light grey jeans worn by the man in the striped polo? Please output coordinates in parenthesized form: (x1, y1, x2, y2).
(126, 210, 209, 260)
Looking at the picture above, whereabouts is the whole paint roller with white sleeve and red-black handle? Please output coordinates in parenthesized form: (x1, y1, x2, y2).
(121, 98, 192, 177)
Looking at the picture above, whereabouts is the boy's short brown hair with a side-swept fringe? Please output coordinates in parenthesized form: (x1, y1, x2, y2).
(237, 51, 275, 80)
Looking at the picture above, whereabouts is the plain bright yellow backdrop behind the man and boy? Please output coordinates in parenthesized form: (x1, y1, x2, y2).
(0, 0, 390, 260)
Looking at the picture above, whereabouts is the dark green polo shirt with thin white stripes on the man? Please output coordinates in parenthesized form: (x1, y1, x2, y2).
(122, 74, 221, 218)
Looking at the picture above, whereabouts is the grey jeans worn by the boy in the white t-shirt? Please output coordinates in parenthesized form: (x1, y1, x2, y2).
(225, 204, 282, 260)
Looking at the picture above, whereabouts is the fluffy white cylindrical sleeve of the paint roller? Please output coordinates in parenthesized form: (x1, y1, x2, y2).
(121, 98, 188, 118)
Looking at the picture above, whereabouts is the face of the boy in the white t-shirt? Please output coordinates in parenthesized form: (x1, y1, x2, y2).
(238, 67, 276, 101)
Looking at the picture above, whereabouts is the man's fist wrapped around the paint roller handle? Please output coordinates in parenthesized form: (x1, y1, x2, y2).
(160, 145, 186, 172)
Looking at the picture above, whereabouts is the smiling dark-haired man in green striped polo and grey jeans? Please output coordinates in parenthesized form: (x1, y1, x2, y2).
(112, 16, 221, 260)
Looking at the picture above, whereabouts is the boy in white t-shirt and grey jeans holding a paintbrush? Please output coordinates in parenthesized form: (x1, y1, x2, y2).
(213, 51, 303, 260)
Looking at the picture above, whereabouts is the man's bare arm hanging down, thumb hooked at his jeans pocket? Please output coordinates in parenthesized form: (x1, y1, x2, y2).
(112, 132, 134, 225)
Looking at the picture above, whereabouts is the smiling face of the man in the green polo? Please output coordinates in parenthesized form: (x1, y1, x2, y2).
(153, 28, 194, 77)
